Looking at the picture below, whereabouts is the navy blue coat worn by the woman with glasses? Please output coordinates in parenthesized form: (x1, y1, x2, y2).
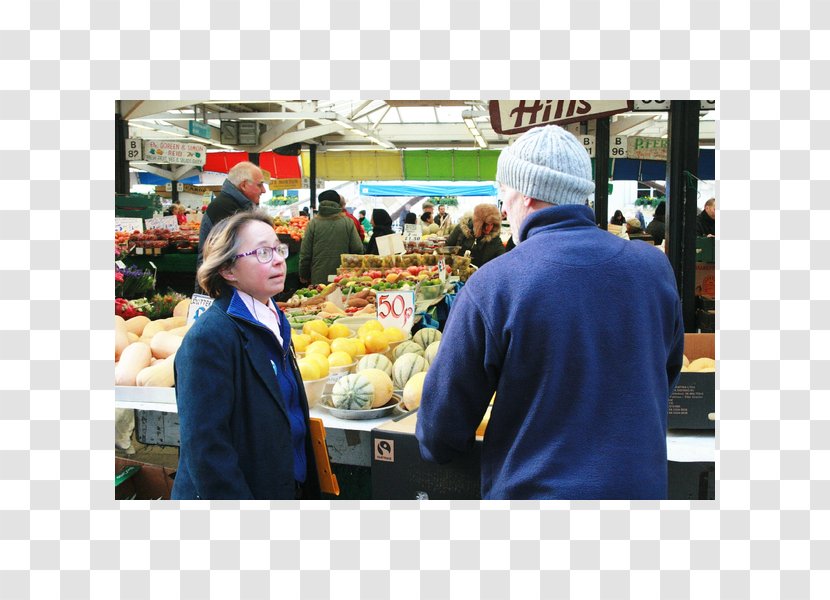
(171, 289, 320, 500)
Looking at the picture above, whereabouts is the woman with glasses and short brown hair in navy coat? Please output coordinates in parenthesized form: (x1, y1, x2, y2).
(172, 211, 320, 500)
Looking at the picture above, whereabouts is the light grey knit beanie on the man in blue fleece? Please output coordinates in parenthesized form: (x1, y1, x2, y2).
(496, 125, 594, 204)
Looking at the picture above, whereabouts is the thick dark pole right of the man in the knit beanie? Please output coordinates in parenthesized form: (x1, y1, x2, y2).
(666, 100, 700, 333)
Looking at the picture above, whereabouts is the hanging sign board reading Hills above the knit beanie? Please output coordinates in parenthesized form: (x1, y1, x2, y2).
(490, 100, 633, 135)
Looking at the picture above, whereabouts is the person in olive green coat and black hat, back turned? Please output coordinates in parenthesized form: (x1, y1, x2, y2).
(300, 190, 363, 285)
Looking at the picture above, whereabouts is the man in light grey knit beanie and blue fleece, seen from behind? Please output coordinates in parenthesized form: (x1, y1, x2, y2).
(416, 125, 684, 500)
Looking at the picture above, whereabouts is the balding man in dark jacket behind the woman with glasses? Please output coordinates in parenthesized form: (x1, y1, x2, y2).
(196, 161, 265, 292)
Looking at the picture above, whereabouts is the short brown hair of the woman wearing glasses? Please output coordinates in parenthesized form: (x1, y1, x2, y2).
(196, 210, 274, 298)
